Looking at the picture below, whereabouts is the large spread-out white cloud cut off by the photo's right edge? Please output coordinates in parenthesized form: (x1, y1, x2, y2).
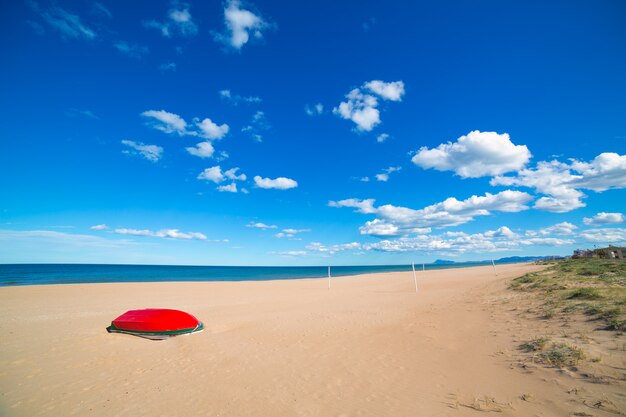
(490, 152, 626, 213)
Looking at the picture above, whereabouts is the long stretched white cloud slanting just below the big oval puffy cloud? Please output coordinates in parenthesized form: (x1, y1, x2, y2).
(328, 190, 533, 236)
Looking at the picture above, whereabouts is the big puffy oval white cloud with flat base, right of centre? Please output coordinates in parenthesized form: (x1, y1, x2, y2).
(411, 130, 531, 178)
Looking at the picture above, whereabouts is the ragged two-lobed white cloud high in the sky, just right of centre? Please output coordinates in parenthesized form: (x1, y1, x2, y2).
(333, 80, 404, 132)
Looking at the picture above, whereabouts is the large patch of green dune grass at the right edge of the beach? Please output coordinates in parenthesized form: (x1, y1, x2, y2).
(511, 259, 626, 330)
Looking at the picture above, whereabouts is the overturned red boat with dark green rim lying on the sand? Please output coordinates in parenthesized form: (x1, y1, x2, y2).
(107, 308, 204, 340)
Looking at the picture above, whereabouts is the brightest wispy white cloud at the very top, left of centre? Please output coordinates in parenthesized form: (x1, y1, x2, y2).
(215, 0, 271, 50)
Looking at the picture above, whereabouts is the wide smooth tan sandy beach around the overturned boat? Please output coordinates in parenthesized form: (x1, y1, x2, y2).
(0, 264, 626, 417)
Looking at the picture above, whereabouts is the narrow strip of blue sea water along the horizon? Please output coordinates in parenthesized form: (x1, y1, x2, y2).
(0, 262, 492, 286)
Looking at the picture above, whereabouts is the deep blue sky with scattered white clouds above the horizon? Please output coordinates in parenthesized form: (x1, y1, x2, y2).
(0, 0, 626, 265)
